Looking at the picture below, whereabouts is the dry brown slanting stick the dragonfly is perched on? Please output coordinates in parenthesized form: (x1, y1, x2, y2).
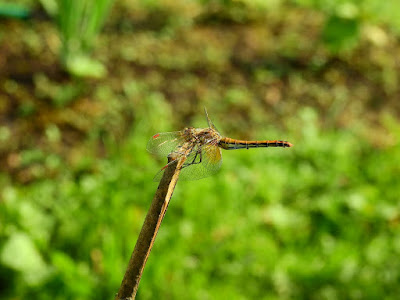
(115, 158, 185, 300)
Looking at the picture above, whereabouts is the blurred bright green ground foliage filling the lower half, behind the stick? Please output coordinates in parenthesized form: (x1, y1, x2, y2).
(0, 106, 400, 299)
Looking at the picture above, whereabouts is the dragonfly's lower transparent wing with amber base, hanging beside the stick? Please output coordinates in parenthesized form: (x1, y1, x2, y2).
(154, 144, 222, 181)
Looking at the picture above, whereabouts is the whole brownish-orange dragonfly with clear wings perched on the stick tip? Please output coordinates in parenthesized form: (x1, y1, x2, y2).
(147, 108, 293, 181)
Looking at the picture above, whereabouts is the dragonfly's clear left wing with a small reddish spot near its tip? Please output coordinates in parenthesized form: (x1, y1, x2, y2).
(147, 131, 184, 158)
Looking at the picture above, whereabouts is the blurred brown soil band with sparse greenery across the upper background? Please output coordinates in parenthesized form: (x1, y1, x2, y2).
(0, 4, 400, 183)
